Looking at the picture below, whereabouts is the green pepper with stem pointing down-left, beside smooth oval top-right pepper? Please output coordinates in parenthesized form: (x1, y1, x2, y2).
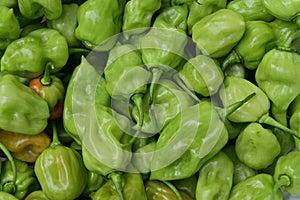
(222, 21, 274, 70)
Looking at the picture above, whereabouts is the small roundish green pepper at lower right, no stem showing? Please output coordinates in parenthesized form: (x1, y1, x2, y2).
(235, 123, 281, 170)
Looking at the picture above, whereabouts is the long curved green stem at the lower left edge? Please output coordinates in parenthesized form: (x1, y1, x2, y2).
(0, 142, 17, 194)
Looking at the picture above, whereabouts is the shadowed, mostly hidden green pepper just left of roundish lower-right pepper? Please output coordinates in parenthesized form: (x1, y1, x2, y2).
(222, 144, 257, 185)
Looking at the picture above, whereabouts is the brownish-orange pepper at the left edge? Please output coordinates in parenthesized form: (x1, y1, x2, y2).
(0, 130, 51, 163)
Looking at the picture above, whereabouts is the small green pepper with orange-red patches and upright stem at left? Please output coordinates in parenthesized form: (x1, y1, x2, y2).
(29, 65, 65, 119)
